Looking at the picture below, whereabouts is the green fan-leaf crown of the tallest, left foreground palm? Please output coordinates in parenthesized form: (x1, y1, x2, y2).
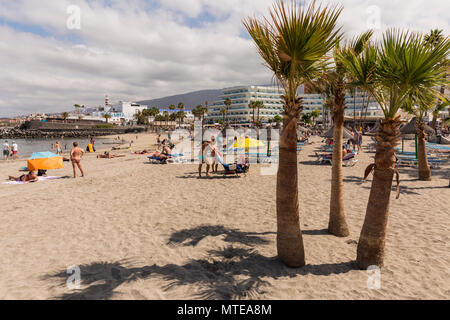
(244, 1, 342, 100)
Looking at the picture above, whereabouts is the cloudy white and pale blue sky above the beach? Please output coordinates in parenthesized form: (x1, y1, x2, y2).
(0, 0, 450, 117)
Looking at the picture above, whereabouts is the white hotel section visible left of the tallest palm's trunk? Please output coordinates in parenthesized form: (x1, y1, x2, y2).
(205, 86, 283, 124)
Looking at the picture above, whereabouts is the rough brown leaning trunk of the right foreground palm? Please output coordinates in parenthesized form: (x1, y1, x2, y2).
(356, 117, 401, 269)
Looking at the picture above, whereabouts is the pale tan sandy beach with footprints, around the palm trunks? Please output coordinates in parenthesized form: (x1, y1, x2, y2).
(0, 134, 450, 300)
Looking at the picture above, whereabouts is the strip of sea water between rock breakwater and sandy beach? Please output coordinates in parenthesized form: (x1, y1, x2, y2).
(0, 138, 117, 160)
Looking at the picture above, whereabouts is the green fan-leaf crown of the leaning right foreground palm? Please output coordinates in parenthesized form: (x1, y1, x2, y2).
(338, 29, 450, 119)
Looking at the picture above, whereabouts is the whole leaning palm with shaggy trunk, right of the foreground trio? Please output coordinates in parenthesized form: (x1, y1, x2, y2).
(341, 30, 450, 269)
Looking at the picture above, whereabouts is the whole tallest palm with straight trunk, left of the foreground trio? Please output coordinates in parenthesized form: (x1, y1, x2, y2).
(244, 1, 342, 267)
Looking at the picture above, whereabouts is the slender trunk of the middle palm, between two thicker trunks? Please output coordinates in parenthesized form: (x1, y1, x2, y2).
(328, 82, 350, 237)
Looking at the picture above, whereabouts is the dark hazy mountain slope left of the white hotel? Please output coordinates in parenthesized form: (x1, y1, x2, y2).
(138, 89, 222, 110)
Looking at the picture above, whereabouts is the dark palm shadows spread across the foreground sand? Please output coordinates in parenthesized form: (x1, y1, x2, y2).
(44, 226, 357, 300)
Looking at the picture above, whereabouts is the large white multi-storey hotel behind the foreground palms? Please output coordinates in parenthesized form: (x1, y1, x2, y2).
(206, 86, 383, 124)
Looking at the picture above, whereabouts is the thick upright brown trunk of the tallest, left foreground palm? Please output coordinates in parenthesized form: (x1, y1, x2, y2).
(276, 100, 305, 267)
